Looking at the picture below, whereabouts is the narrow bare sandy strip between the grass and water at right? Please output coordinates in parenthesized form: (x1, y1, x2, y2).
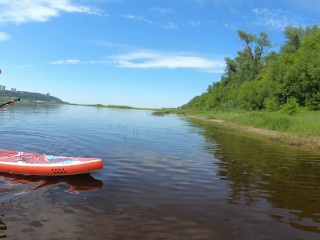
(186, 115, 320, 151)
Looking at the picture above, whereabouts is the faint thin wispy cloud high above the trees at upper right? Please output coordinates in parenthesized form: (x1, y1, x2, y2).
(252, 8, 303, 30)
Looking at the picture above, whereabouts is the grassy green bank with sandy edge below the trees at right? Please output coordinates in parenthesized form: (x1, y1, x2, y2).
(156, 109, 320, 151)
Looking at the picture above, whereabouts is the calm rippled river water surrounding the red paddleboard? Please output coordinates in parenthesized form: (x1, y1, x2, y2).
(0, 104, 320, 240)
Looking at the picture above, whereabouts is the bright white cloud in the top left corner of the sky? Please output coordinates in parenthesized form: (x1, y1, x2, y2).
(0, 0, 98, 24)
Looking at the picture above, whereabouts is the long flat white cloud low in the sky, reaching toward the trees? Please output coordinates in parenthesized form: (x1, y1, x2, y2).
(107, 51, 225, 73)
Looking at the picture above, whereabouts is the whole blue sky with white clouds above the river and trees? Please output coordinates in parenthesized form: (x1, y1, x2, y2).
(0, 0, 320, 108)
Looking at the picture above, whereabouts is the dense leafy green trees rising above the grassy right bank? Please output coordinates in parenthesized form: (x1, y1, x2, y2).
(181, 26, 320, 112)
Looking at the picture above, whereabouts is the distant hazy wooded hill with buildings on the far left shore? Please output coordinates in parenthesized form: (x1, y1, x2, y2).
(0, 90, 64, 103)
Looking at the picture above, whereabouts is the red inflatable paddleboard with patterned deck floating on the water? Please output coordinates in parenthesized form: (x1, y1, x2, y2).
(0, 149, 103, 176)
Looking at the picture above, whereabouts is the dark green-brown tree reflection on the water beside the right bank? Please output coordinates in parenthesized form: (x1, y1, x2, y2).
(189, 121, 320, 232)
